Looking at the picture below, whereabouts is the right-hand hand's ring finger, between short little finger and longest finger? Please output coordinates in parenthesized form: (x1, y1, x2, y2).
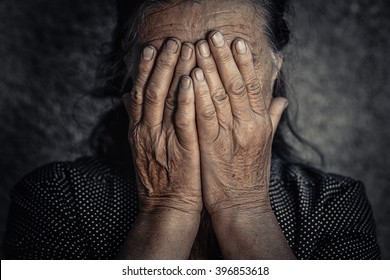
(196, 40, 233, 126)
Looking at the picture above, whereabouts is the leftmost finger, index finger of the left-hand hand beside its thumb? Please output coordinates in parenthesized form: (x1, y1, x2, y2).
(122, 46, 156, 127)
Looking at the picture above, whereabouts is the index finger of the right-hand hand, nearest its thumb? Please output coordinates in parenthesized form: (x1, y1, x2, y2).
(232, 39, 267, 115)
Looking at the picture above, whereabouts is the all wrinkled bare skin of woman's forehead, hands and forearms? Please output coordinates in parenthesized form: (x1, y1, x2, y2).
(122, 0, 291, 258)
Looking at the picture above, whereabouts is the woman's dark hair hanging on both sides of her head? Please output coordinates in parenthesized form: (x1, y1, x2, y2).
(90, 0, 316, 173)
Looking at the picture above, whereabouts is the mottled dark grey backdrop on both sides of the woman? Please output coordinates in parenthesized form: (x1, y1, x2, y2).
(0, 0, 390, 259)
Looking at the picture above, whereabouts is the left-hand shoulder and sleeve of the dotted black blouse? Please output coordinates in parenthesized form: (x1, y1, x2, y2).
(4, 157, 137, 259)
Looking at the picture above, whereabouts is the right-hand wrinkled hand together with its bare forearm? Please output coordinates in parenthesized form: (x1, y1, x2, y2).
(192, 32, 291, 258)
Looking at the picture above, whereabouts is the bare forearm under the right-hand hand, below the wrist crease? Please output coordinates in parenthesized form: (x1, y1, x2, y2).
(211, 206, 294, 259)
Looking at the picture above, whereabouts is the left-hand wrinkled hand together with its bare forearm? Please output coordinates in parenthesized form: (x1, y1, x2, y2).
(119, 39, 203, 259)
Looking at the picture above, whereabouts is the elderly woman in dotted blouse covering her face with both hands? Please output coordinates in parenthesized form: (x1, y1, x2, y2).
(5, 0, 379, 259)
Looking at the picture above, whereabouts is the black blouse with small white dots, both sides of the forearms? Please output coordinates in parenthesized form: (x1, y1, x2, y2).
(4, 158, 380, 259)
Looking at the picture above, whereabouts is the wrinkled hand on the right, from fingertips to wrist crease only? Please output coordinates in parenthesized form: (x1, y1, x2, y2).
(192, 32, 287, 217)
